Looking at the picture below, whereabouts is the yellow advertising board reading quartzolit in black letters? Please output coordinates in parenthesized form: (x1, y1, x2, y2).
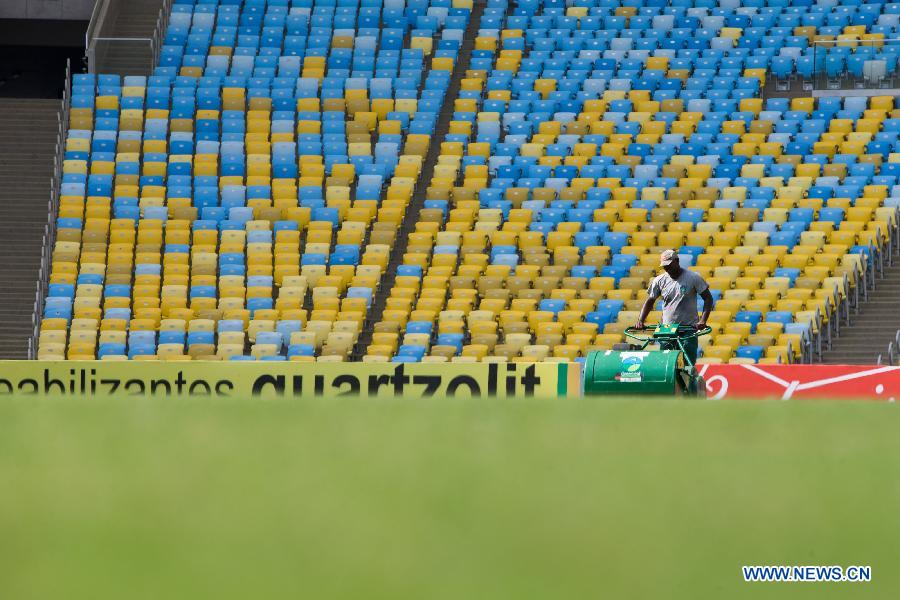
(0, 361, 581, 399)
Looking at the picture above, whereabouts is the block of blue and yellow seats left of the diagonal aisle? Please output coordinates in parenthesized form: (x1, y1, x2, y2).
(39, 0, 471, 361)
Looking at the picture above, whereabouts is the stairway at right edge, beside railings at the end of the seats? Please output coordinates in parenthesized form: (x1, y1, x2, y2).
(822, 256, 900, 365)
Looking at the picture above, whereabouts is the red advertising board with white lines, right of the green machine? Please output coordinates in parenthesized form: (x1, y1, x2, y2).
(700, 365, 900, 402)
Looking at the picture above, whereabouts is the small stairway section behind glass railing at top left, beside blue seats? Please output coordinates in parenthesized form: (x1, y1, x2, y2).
(100, 0, 169, 75)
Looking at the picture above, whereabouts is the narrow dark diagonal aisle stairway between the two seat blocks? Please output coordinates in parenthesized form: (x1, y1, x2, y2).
(352, 0, 484, 361)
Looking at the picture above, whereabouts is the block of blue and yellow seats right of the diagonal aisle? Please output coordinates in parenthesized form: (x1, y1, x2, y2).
(367, 2, 897, 362)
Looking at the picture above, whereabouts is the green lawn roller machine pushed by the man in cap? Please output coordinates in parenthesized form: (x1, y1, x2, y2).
(584, 325, 712, 398)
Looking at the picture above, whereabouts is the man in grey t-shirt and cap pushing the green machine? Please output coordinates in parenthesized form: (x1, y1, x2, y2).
(635, 250, 715, 362)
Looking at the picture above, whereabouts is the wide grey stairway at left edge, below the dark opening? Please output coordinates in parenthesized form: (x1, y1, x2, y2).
(0, 98, 59, 359)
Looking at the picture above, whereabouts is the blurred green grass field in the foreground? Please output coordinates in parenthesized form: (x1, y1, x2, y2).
(0, 399, 900, 600)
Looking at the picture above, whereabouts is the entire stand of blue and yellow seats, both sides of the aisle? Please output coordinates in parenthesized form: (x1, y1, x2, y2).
(39, 0, 900, 362)
